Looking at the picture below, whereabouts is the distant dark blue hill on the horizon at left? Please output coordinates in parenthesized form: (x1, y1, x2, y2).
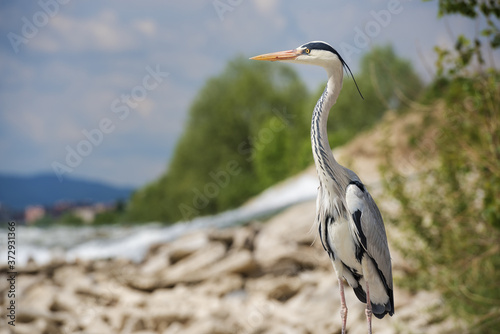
(0, 173, 134, 210)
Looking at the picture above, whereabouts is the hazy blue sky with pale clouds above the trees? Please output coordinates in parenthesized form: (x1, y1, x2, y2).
(0, 0, 500, 187)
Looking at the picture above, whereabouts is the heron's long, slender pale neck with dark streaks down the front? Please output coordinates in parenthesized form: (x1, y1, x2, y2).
(311, 67, 343, 180)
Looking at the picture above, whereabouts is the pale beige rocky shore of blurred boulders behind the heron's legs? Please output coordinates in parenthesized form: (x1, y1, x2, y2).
(0, 198, 453, 334)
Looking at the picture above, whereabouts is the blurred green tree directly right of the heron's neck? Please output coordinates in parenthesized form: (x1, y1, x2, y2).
(311, 45, 423, 146)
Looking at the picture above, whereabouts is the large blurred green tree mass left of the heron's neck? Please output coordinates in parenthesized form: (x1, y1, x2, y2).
(128, 58, 312, 222)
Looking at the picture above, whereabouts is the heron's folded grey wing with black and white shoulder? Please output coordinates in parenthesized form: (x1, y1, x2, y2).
(346, 181, 392, 289)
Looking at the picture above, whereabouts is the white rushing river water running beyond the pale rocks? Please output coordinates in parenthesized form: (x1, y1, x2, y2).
(0, 174, 318, 267)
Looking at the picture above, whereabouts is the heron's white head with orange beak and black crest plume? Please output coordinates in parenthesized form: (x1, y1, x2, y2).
(250, 41, 363, 97)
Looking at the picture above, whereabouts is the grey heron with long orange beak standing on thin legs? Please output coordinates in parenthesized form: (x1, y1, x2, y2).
(251, 41, 394, 333)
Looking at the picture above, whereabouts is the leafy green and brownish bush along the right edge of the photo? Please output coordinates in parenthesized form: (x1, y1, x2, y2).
(383, 0, 500, 333)
